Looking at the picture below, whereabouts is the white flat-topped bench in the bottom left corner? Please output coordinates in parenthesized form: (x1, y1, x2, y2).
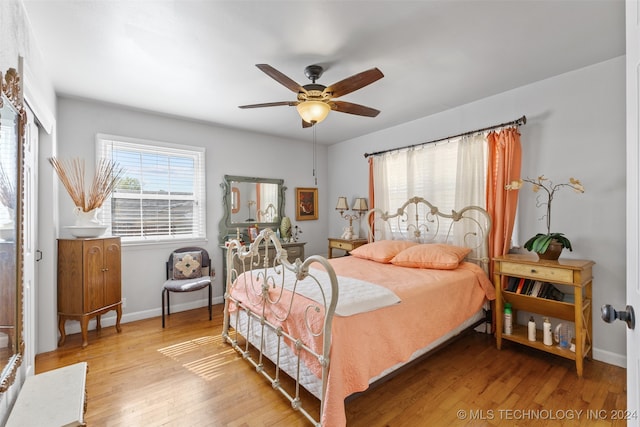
(6, 362, 87, 427)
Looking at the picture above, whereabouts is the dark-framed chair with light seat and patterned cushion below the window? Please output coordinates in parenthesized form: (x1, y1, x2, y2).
(162, 246, 215, 328)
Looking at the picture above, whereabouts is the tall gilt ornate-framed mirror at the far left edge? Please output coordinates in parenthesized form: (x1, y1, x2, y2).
(0, 68, 26, 393)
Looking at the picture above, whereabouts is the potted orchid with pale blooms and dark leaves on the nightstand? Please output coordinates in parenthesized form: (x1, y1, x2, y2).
(505, 175, 584, 259)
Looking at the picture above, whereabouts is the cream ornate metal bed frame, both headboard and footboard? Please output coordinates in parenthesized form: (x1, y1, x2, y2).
(222, 197, 491, 426)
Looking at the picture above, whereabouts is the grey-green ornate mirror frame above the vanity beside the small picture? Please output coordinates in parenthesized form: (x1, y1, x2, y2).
(218, 175, 287, 243)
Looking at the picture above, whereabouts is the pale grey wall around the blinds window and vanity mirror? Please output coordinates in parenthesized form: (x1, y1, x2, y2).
(49, 97, 328, 342)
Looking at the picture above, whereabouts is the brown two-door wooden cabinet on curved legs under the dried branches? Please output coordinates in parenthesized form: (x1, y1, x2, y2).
(58, 237, 122, 347)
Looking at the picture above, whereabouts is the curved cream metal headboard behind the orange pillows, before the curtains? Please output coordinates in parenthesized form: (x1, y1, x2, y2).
(365, 197, 491, 273)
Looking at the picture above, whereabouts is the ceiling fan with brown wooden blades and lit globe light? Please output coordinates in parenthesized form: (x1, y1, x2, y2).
(239, 64, 384, 128)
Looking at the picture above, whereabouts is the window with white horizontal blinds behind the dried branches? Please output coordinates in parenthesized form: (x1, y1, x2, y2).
(96, 134, 206, 246)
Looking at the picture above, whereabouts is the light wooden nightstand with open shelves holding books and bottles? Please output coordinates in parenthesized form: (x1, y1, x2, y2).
(493, 255, 594, 377)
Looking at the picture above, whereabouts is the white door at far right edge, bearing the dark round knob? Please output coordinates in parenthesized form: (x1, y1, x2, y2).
(626, 0, 640, 427)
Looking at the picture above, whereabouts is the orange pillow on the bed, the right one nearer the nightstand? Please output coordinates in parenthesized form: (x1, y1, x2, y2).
(391, 243, 471, 270)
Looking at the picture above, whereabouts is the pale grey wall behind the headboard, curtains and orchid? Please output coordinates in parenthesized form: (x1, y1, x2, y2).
(328, 57, 626, 366)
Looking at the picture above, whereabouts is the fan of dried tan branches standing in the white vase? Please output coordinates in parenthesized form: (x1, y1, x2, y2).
(49, 157, 124, 212)
